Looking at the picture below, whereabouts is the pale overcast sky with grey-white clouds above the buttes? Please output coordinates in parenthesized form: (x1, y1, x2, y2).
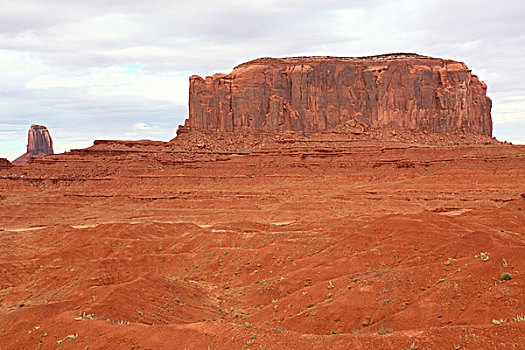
(0, 0, 525, 160)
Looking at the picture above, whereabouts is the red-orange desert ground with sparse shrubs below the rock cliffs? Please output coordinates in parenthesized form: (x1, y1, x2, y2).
(0, 54, 525, 349)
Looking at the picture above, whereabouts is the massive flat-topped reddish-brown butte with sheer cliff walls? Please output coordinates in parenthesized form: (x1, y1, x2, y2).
(179, 54, 492, 136)
